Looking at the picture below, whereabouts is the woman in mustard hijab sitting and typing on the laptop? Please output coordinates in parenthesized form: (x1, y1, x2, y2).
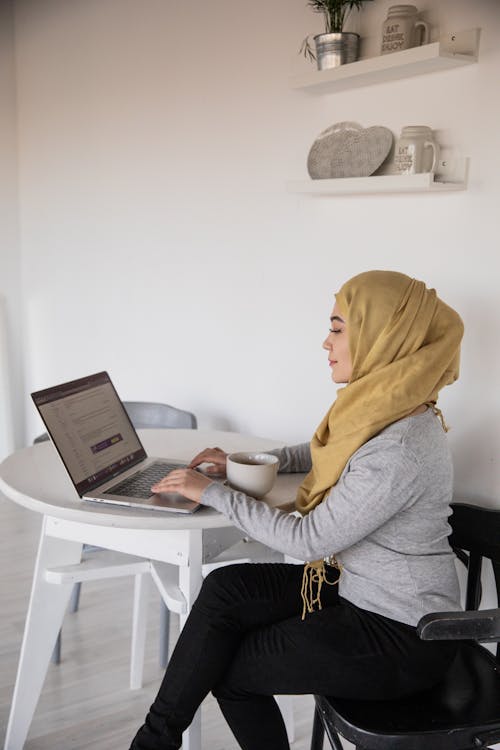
(132, 271, 463, 750)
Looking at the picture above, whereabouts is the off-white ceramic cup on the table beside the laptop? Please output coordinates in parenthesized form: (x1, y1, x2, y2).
(226, 453, 279, 500)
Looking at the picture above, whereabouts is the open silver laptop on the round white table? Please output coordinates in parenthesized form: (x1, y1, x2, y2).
(31, 372, 200, 513)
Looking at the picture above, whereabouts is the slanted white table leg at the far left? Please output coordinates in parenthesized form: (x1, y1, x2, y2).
(4, 518, 82, 750)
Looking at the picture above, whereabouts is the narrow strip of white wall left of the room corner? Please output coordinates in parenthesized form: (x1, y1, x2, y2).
(0, 0, 24, 460)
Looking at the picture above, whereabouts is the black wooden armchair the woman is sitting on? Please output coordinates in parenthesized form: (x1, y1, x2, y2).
(311, 503, 500, 750)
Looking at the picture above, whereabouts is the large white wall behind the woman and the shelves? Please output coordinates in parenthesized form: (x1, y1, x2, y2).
(11, 0, 500, 503)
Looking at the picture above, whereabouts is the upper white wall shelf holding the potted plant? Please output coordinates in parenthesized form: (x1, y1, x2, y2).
(292, 29, 481, 94)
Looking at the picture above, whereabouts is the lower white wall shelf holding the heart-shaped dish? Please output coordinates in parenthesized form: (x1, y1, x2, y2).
(287, 159, 469, 195)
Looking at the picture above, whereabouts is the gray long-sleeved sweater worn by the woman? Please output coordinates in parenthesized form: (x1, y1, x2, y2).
(202, 409, 460, 625)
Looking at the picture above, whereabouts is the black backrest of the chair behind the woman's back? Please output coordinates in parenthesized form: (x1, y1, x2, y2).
(450, 503, 500, 662)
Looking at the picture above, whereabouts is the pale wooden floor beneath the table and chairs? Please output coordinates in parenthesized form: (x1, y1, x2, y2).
(0, 495, 336, 750)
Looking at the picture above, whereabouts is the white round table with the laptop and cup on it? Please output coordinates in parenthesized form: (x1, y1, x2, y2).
(0, 429, 302, 750)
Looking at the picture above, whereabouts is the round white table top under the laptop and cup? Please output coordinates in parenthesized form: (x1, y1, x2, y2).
(0, 430, 302, 529)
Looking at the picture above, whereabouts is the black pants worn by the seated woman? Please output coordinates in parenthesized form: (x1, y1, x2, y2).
(131, 564, 455, 750)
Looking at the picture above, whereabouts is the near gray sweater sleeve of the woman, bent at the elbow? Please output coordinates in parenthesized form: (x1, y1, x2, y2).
(201, 439, 419, 560)
